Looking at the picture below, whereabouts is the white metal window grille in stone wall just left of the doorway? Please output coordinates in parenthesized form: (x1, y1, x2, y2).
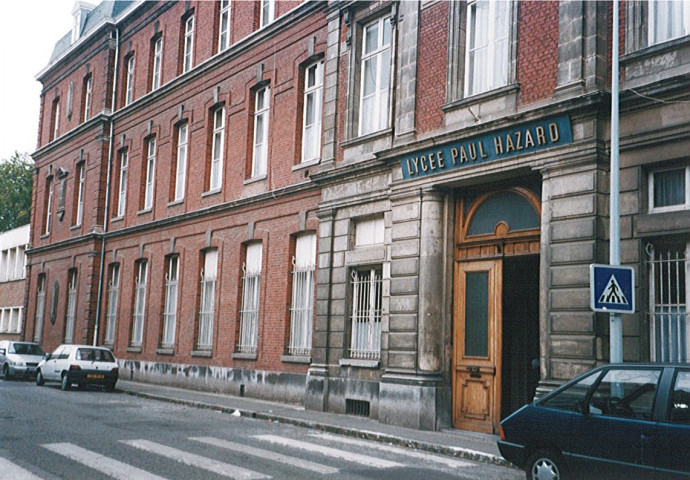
(350, 268, 383, 359)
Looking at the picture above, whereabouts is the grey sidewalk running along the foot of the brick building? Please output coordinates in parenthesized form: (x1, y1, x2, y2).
(117, 380, 512, 466)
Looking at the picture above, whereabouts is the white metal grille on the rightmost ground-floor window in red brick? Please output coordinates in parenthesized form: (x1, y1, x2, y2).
(288, 257, 314, 355)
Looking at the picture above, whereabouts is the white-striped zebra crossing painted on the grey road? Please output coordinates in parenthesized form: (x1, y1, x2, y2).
(0, 433, 474, 480)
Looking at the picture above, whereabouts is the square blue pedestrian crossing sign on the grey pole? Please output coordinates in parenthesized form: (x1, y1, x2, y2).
(589, 264, 635, 313)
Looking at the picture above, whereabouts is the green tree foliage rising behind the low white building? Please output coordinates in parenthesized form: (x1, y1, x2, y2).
(0, 152, 34, 232)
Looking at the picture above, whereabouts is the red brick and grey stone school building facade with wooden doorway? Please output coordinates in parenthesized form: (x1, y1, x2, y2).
(27, 0, 690, 432)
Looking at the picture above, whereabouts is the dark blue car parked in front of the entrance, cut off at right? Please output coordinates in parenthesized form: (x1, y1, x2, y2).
(498, 364, 690, 480)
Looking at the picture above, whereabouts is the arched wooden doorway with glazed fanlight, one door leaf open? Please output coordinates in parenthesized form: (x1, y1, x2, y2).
(453, 187, 541, 433)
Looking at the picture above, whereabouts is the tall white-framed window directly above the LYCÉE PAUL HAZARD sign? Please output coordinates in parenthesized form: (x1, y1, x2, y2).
(464, 0, 513, 97)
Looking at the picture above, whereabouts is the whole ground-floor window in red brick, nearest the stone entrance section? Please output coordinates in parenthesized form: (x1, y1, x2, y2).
(288, 233, 316, 356)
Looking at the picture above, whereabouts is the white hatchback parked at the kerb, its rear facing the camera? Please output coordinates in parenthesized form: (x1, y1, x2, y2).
(36, 344, 118, 392)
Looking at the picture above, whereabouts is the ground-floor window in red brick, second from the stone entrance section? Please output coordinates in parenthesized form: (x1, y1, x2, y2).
(237, 243, 262, 353)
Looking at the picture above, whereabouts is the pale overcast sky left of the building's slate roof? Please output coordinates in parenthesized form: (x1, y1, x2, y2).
(0, 0, 74, 160)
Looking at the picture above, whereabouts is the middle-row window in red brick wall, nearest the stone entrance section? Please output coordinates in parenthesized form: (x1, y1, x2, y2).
(302, 62, 323, 162)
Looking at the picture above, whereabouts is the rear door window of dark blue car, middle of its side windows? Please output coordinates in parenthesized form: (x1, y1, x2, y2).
(589, 369, 661, 420)
